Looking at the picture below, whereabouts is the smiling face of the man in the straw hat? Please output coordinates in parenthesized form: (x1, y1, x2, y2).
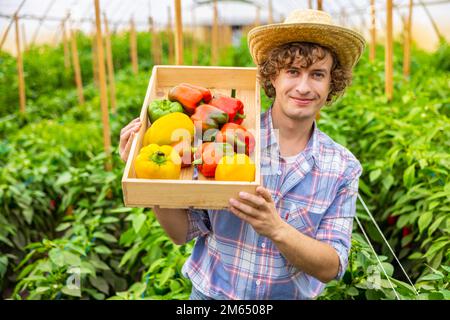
(271, 52, 333, 121)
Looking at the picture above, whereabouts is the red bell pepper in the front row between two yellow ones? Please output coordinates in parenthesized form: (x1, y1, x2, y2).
(193, 142, 234, 178)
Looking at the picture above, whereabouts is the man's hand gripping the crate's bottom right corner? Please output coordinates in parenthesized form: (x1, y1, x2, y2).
(230, 186, 286, 239)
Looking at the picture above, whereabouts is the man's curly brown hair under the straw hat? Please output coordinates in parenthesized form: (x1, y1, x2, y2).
(258, 42, 352, 104)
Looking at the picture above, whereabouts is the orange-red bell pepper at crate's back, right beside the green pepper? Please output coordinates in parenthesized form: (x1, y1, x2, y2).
(168, 83, 211, 115)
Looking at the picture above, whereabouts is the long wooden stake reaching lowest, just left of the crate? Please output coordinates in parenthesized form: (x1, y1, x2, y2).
(94, 0, 112, 171)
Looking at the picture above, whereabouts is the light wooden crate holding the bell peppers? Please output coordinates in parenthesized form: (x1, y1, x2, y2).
(122, 66, 261, 209)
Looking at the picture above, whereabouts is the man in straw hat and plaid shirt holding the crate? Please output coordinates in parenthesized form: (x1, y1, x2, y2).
(120, 10, 364, 299)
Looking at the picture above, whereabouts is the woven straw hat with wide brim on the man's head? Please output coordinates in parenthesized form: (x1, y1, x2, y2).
(248, 9, 365, 69)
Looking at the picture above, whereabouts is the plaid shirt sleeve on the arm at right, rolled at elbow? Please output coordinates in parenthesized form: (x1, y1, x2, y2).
(316, 162, 362, 280)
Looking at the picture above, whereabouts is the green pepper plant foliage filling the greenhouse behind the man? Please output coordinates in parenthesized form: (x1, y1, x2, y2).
(0, 32, 450, 300)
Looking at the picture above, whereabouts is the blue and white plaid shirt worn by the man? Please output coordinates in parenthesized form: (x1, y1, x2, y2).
(183, 109, 362, 299)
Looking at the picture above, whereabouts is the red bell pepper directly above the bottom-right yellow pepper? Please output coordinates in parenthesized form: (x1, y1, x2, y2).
(215, 122, 256, 155)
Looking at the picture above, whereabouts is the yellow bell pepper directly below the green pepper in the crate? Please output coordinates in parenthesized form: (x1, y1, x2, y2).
(143, 112, 194, 146)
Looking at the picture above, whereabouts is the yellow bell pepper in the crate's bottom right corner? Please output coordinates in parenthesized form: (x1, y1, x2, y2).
(215, 153, 256, 182)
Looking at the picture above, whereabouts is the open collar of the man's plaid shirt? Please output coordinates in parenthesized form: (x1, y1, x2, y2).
(261, 105, 320, 168)
